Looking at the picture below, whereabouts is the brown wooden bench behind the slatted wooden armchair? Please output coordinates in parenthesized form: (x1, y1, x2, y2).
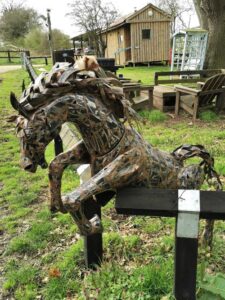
(153, 69, 223, 112)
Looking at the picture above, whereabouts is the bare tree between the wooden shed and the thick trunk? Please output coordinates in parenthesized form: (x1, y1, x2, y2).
(155, 0, 193, 34)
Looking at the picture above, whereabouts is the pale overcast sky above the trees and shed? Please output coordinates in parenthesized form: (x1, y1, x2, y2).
(22, 0, 198, 37)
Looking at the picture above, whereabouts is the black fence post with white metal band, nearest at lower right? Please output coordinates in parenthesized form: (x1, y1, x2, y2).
(174, 190, 200, 300)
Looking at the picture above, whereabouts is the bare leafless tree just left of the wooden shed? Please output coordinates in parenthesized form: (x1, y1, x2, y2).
(68, 0, 118, 57)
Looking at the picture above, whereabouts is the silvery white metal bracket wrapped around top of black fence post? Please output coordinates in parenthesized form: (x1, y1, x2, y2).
(177, 190, 200, 239)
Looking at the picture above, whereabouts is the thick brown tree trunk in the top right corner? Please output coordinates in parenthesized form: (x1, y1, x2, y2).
(193, 0, 225, 69)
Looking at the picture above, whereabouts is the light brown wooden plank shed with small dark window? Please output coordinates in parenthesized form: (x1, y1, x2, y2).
(104, 4, 171, 65)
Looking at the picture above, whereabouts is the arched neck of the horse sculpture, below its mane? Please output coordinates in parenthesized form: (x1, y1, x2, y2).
(63, 94, 125, 156)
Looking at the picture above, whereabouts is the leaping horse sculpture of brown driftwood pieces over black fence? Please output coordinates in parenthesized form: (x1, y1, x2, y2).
(11, 61, 221, 239)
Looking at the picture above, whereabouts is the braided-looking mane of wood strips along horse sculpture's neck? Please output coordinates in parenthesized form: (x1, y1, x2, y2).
(15, 64, 139, 125)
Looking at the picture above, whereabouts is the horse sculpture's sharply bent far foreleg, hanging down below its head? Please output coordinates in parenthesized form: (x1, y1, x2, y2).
(49, 141, 90, 212)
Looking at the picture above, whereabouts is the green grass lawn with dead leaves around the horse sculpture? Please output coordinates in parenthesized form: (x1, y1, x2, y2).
(0, 67, 225, 300)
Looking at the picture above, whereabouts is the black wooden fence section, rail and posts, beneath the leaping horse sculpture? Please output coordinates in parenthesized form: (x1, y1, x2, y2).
(80, 187, 225, 300)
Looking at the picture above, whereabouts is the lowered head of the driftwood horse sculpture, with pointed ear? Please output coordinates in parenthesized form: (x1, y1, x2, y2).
(10, 94, 61, 173)
